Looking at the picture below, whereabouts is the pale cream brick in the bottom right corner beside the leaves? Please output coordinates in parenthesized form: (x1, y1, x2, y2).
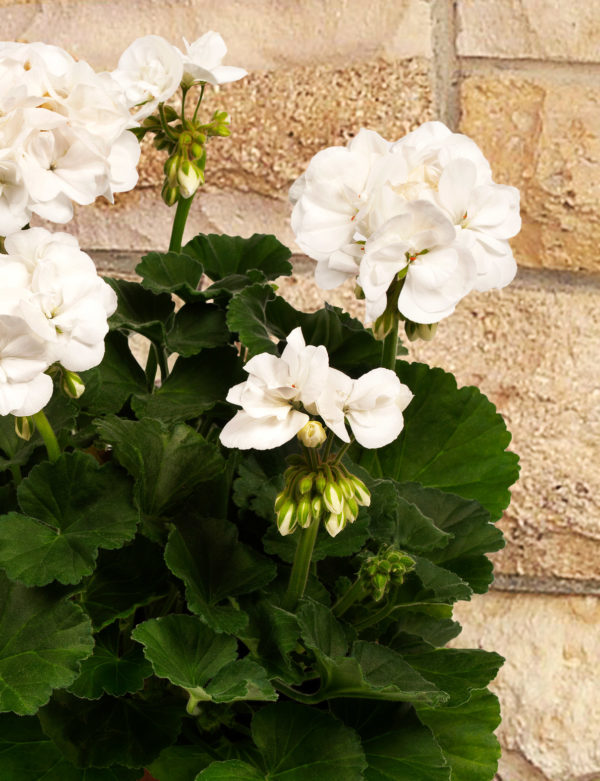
(452, 592, 600, 781)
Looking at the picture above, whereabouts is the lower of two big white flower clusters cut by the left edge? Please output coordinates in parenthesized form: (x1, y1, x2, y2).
(0, 228, 117, 416)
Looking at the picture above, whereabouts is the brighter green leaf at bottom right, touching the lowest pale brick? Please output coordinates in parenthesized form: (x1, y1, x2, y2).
(417, 689, 500, 781)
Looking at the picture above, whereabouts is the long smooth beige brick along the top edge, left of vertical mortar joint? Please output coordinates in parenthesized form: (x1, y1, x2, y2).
(0, 0, 431, 70)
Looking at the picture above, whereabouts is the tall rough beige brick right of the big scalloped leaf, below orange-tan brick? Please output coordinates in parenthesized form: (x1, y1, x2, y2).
(280, 261, 600, 580)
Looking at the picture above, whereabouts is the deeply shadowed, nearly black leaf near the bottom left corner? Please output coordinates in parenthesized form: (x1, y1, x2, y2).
(39, 692, 183, 768)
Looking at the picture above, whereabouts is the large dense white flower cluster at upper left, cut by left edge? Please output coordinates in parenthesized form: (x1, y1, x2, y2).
(0, 42, 140, 236)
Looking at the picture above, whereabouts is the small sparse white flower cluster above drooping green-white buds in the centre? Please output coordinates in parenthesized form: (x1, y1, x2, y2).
(221, 328, 412, 450)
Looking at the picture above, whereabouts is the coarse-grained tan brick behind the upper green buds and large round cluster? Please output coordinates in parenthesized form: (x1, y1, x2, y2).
(140, 59, 433, 197)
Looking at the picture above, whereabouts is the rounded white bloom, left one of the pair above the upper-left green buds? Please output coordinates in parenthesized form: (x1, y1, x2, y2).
(112, 35, 183, 120)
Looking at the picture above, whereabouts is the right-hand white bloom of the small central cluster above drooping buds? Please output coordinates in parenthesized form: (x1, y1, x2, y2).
(316, 369, 413, 448)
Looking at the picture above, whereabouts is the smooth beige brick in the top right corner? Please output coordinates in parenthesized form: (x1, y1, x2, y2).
(457, 0, 600, 62)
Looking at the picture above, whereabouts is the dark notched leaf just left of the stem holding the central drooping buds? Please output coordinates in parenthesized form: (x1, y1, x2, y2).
(165, 516, 276, 633)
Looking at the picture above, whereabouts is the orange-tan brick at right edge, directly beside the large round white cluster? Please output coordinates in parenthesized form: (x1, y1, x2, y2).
(461, 71, 600, 270)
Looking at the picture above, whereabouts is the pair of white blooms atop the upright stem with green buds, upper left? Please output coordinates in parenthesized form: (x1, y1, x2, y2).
(112, 30, 247, 120)
